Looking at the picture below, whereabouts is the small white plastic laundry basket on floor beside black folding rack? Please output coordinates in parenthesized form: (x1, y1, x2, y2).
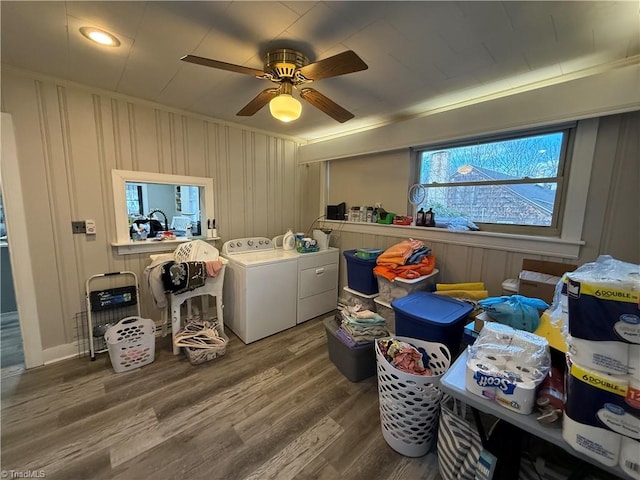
(104, 317, 156, 373)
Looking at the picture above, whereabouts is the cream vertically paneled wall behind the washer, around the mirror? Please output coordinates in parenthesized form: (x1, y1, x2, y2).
(2, 68, 301, 357)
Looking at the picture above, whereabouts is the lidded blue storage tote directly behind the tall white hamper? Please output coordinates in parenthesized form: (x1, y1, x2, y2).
(391, 292, 473, 357)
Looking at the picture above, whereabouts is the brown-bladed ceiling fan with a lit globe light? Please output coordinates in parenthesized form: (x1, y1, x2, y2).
(180, 48, 369, 123)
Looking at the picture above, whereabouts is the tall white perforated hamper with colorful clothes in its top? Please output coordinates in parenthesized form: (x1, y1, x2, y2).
(375, 337, 451, 457)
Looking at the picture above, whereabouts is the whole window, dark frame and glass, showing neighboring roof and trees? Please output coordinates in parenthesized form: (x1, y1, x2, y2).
(416, 126, 573, 235)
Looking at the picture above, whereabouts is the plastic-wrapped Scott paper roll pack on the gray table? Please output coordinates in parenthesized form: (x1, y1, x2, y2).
(465, 322, 551, 415)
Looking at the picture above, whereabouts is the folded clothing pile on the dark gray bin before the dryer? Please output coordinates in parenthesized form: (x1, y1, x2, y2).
(336, 305, 389, 347)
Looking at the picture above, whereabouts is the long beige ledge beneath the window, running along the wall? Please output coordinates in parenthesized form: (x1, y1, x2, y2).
(323, 220, 585, 258)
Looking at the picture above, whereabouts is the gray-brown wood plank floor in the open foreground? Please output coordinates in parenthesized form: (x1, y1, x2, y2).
(1, 318, 440, 480)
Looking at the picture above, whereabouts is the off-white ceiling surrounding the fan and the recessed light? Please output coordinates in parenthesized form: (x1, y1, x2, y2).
(0, 0, 640, 140)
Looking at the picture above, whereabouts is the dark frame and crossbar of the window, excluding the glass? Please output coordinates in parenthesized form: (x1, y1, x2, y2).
(408, 122, 578, 237)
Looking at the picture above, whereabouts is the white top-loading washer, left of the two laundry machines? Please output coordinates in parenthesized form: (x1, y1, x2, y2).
(221, 237, 298, 343)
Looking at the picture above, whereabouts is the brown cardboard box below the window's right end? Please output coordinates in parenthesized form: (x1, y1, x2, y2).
(518, 258, 578, 305)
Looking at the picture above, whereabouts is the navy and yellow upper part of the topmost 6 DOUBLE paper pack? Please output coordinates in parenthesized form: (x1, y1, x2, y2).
(567, 255, 640, 344)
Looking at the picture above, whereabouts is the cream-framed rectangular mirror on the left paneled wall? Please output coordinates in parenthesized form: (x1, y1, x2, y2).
(111, 170, 215, 245)
